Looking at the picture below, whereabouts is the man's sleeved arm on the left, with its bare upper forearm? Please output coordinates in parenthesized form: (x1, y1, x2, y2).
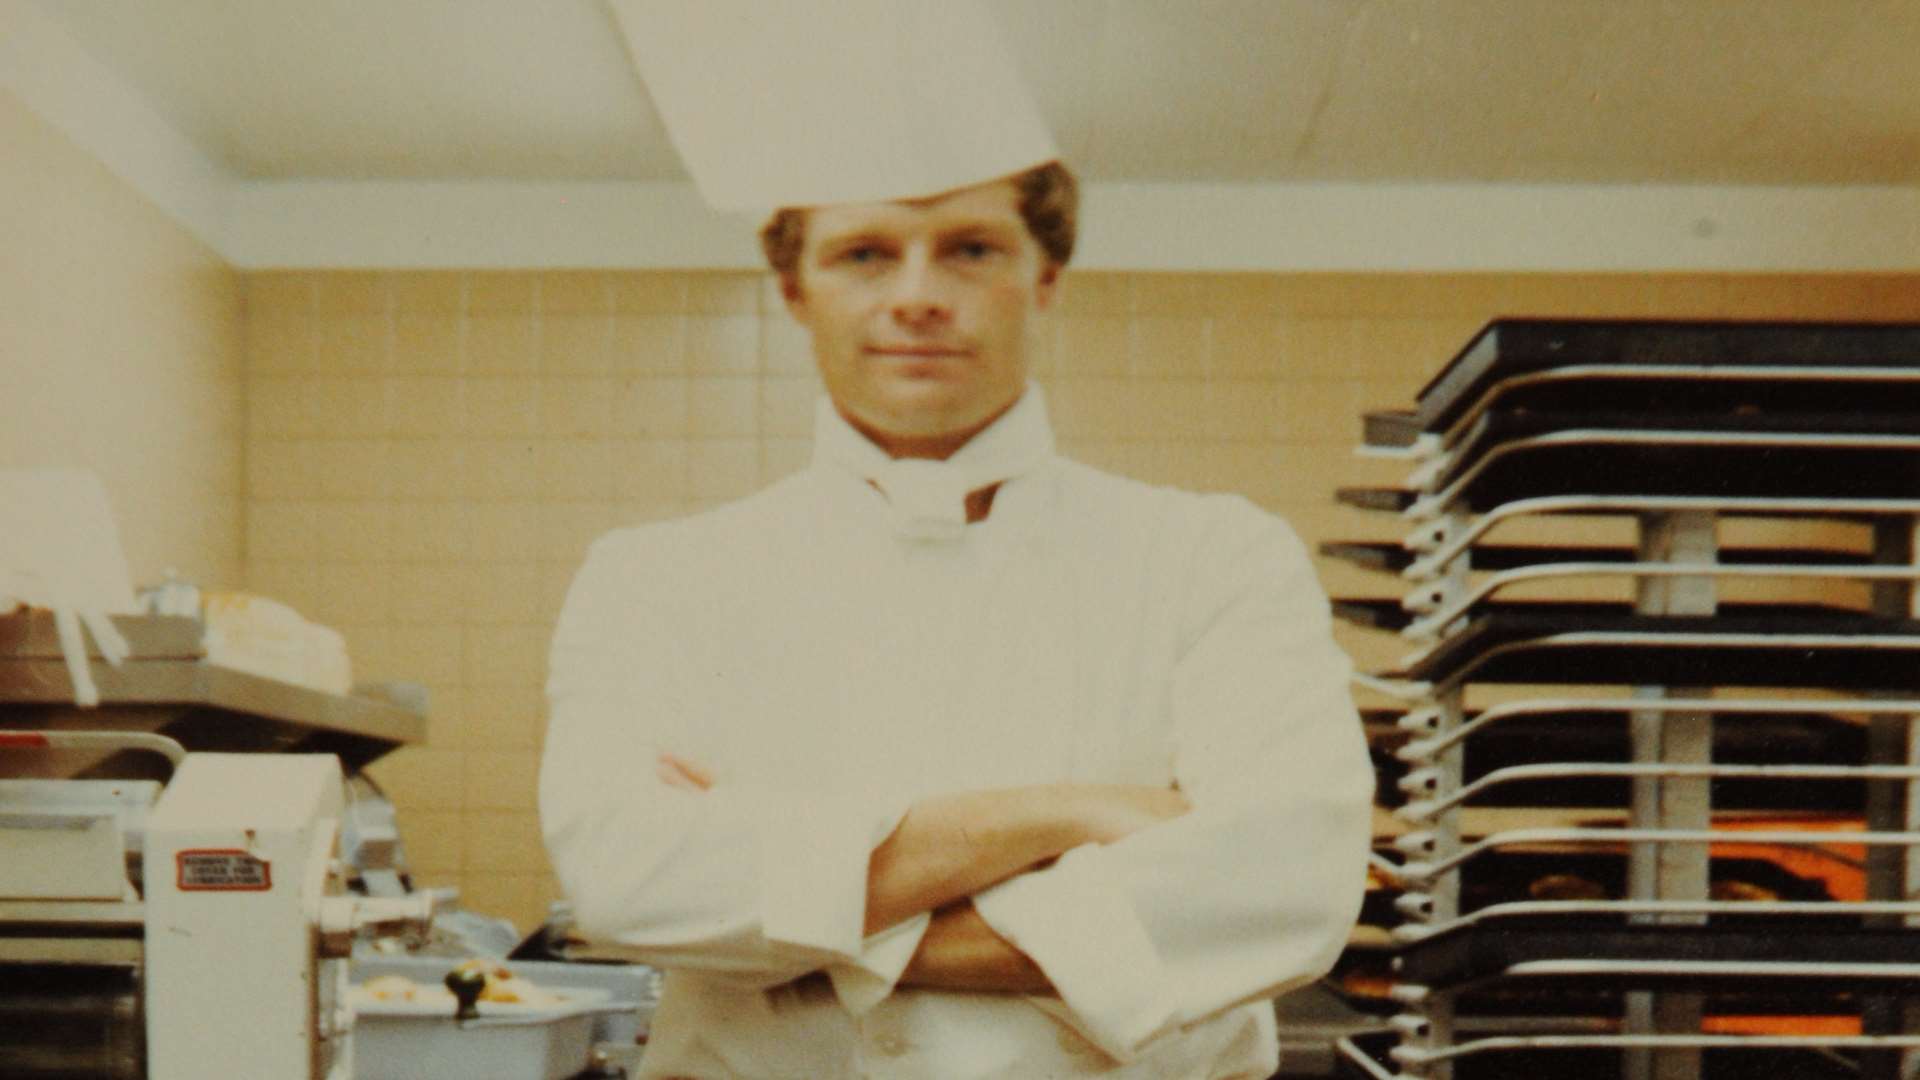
(541, 522, 1171, 995)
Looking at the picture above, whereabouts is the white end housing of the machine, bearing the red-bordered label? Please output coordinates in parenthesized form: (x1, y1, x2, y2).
(146, 753, 432, 1080)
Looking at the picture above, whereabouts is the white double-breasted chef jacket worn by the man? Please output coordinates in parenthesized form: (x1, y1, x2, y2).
(541, 388, 1373, 1080)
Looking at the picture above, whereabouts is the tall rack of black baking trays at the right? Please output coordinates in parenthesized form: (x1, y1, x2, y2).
(1325, 321, 1920, 1080)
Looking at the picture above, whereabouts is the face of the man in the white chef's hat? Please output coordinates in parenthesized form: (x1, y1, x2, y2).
(787, 181, 1058, 457)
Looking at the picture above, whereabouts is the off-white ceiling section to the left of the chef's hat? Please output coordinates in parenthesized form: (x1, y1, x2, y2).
(31, 0, 684, 179)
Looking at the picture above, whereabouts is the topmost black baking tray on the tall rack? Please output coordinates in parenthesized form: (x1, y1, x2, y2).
(1402, 319, 1920, 432)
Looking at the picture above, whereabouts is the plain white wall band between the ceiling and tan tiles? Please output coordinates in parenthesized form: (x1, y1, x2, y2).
(11, 0, 1920, 271)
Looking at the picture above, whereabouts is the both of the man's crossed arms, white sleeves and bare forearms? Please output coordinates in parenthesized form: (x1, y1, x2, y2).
(541, 499, 1371, 1037)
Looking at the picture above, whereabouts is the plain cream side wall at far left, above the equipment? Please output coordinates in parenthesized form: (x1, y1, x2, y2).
(0, 90, 244, 588)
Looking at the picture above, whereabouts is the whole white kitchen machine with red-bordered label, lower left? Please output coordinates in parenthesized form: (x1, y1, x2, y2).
(0, 732, 432, 1080)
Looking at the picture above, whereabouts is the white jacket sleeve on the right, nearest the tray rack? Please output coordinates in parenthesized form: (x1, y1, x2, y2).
(973, 500, 1373, 1061)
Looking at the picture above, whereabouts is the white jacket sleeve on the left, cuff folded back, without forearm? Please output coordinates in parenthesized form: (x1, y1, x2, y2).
(540, 530, 925, 988)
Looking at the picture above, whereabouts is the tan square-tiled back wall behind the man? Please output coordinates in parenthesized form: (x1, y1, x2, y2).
(246, 273, 1920, 926)
